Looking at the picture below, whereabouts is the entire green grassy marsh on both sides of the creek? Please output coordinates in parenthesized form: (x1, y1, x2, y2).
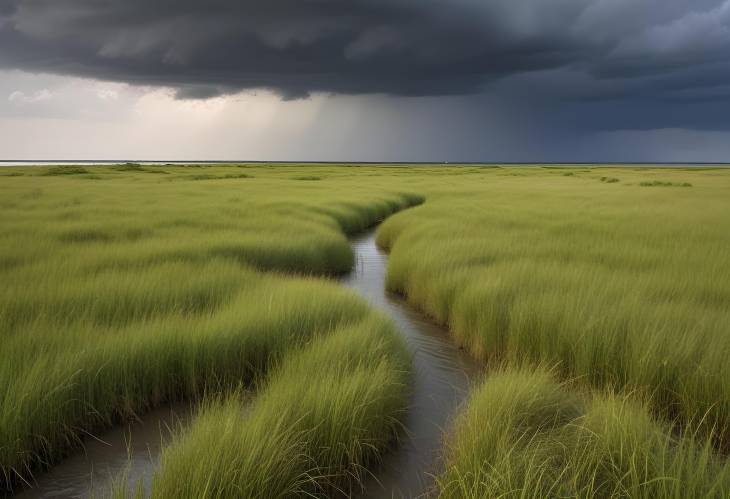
(0, 165, 730, 497)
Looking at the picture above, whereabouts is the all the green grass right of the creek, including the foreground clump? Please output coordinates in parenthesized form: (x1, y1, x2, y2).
(378, 168, 730, 497)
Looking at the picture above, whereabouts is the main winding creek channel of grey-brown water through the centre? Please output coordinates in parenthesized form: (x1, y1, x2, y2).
(342, 231, 481, 498)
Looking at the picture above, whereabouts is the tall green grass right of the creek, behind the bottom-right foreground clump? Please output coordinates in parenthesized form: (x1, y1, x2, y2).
(378, 169, 730, 450)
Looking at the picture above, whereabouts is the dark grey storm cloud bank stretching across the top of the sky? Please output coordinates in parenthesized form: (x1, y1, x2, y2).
(0, 0, 730, 108)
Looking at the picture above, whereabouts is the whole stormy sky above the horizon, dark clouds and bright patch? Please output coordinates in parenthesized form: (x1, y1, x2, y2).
(0, 0, 730, 162)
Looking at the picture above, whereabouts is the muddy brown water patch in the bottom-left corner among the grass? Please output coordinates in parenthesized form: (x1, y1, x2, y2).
(15, 404, 190, 499)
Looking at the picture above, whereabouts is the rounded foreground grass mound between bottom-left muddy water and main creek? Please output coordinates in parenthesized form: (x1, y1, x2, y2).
(145, 319, 408, 498)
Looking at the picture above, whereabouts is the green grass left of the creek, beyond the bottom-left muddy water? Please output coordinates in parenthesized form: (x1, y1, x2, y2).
(0, 168, 420, 490)
